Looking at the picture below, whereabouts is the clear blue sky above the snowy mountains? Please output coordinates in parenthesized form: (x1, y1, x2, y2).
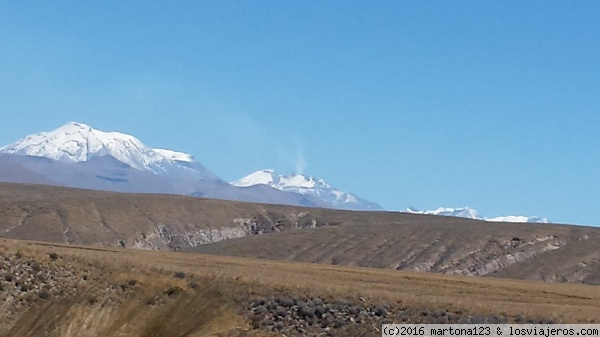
(0, 0, 600, 225)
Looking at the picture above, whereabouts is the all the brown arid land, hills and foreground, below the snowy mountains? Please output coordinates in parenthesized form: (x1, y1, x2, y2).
(0, 184, 600, 336)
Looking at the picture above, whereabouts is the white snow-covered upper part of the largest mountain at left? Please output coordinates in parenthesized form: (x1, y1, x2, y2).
(0, 122, 219, 179)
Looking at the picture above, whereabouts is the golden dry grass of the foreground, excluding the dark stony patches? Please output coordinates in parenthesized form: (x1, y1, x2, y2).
(0, 235, 600, 336)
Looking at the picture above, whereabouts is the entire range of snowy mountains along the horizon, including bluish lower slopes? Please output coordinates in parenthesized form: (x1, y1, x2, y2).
(0, 122, 548, 222)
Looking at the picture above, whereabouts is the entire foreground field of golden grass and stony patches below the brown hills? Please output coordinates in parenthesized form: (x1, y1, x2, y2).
(0, 240, 600, 336)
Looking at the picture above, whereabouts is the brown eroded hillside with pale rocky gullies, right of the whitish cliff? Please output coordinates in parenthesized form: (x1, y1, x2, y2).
(193, 218, 600, 284)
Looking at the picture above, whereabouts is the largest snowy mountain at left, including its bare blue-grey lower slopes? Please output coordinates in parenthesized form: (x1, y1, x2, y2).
(0, 122, 338, 207)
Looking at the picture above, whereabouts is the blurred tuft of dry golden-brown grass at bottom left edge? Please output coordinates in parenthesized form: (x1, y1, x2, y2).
(5, 272, 246, 337)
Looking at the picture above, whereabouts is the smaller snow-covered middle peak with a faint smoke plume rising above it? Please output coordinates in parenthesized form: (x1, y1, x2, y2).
(231, 169, 383, 210)
